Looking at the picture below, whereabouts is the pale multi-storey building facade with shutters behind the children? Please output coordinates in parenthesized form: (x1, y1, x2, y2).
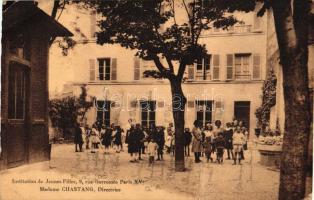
(50, 3, 267, 133)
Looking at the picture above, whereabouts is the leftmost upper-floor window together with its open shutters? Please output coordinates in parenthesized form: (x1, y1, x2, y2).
(89, 58, 117, 81)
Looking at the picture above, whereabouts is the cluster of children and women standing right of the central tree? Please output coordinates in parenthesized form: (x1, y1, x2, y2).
(185, 120, 249, 164)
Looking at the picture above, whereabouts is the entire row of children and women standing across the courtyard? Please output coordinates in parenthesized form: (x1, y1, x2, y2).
(75, 120, 248, 165)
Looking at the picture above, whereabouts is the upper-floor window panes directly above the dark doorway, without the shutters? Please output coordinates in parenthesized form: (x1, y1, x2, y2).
(234, 54, 251, 80)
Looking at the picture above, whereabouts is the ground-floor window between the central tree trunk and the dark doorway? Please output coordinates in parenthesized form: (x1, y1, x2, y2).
(196, 100, 212, 126)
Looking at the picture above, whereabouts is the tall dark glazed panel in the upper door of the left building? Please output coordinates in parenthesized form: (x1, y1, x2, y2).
(9, 63, 26, 119)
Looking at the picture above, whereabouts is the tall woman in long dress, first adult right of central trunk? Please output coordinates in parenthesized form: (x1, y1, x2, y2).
(192, 120, 202, 163)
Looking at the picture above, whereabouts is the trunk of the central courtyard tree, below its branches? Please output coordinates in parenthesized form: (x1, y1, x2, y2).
(170, 79, 186, 172)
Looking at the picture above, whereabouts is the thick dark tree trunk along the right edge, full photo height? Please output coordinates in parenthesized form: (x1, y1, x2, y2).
(271, 0, 311, 200)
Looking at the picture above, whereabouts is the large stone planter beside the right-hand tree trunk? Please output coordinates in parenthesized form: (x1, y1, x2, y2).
(257, 144, 282, 168)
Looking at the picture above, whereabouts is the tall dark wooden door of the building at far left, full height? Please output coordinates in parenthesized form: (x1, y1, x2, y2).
(7, 62, 29, 167)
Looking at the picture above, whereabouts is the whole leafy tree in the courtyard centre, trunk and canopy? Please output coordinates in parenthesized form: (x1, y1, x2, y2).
(88, 0, 255, 171)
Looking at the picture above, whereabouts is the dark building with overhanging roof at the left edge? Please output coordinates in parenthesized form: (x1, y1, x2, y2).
(0, 1, 71, 170)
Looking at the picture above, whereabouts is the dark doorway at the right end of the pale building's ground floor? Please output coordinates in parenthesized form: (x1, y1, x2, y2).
(234, 101, 250, 130)
